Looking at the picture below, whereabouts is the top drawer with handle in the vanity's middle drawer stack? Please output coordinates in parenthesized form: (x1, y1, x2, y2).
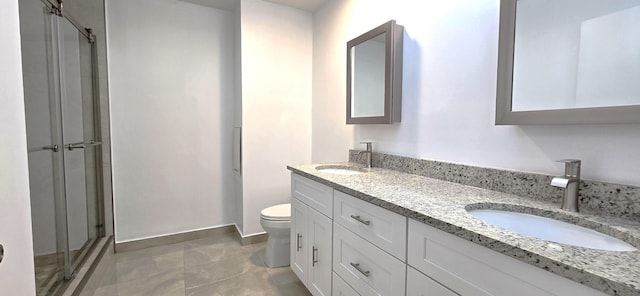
(333, 191, 407, 262)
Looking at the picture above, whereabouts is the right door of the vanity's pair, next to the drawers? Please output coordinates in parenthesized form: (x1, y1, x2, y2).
(307, 208, 333, 296)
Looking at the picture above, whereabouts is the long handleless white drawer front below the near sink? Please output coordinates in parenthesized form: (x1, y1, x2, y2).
(407, 219, 605, 296)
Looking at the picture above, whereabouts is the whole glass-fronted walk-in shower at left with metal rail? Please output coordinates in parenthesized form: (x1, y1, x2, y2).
(19, 0, 104, 295)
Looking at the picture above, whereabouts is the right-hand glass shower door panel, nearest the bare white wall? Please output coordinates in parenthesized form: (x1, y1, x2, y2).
(57, 13, 102, 274)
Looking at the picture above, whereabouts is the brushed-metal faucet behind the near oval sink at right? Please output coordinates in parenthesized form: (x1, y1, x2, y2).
(551, 159, 580, 212)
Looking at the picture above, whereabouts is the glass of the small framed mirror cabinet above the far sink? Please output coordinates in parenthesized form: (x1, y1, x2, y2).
(350, 33, 386, 117)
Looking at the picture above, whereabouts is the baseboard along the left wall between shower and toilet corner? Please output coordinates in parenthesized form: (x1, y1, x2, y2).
(115, 225, 235, 253)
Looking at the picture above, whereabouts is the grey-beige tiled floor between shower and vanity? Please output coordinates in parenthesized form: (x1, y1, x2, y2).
(86, 234, 311, 296)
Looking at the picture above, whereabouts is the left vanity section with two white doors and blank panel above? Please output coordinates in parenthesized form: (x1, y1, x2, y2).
(291, 174, 333, 296)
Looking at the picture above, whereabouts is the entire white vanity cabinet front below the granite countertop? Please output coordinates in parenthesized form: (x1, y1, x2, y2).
(291, 174, 605, 296)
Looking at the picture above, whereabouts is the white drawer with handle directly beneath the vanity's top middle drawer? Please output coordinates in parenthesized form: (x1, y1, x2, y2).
(333, 223, 406, 296)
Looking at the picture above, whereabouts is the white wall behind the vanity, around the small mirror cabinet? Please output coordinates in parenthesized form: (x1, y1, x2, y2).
(313, 0, 640, 185)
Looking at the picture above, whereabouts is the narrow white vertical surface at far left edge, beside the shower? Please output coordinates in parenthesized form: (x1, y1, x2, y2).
(0, 0, 36, 295)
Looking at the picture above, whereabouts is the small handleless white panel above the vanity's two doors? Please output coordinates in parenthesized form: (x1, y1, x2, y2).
(291, 174, 333, 218)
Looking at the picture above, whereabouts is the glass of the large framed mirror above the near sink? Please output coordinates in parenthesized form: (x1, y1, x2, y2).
(512, 0, 640, 111)
